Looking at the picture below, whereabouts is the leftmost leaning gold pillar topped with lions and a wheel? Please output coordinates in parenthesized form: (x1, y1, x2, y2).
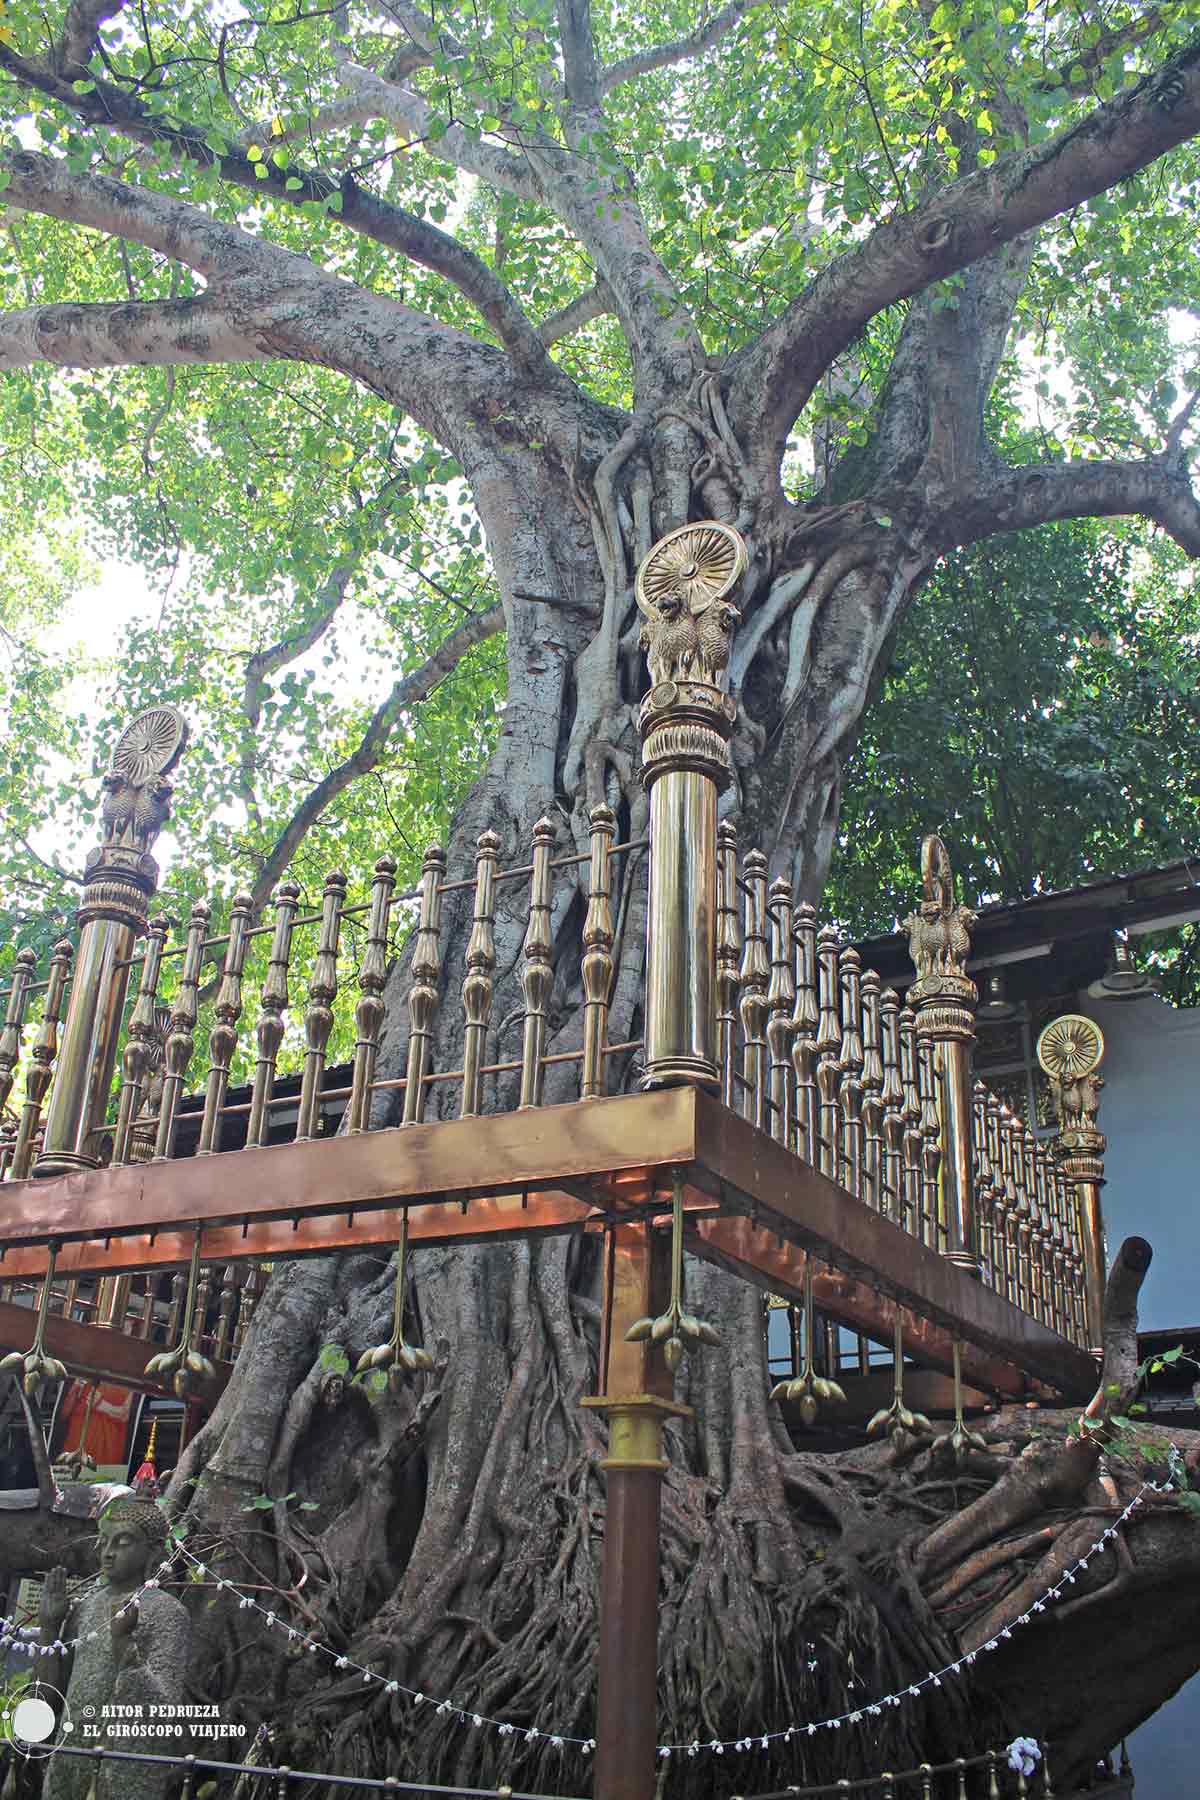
(34, 706, 187, 1175)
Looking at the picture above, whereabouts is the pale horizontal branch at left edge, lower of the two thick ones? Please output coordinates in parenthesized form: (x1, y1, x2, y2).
(0, 295, 273, 369)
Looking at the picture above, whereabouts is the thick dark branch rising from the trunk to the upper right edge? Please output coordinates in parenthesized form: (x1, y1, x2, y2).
(729, 38, 1200, 477)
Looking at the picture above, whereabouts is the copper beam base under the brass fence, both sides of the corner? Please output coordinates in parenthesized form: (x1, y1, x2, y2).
(0, 1087, 1096, 1399)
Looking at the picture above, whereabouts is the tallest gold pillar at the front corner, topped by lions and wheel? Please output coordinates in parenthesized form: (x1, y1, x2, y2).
(637, 520, 747, 1087)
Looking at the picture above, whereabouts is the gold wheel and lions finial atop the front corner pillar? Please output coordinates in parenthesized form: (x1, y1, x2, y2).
(635, 518, 747, 688)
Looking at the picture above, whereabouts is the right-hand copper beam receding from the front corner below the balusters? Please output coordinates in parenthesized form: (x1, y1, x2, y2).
(693, 1094, 1096, 1400)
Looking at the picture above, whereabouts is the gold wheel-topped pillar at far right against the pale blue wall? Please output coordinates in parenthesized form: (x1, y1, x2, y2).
(1038, 1013, 1108, 1355)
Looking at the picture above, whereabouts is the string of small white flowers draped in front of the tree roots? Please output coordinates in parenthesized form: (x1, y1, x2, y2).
(173, 1481, 1169, 1759)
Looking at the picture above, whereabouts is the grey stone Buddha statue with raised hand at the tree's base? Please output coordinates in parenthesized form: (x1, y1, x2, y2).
(41, 1498, 191, 1800)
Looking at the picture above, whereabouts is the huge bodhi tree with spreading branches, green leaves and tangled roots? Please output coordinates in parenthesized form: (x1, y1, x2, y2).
(0, 0, 1200, 1793)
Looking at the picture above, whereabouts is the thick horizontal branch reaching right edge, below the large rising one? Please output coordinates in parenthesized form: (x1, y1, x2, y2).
(932, 450, 1200, 556)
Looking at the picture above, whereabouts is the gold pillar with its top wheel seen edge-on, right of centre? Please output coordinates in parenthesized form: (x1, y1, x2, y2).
(903, 837, 981, 1276)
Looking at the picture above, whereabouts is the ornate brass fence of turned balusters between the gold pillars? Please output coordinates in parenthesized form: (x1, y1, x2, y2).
(0, 806, 1103, 1361)
